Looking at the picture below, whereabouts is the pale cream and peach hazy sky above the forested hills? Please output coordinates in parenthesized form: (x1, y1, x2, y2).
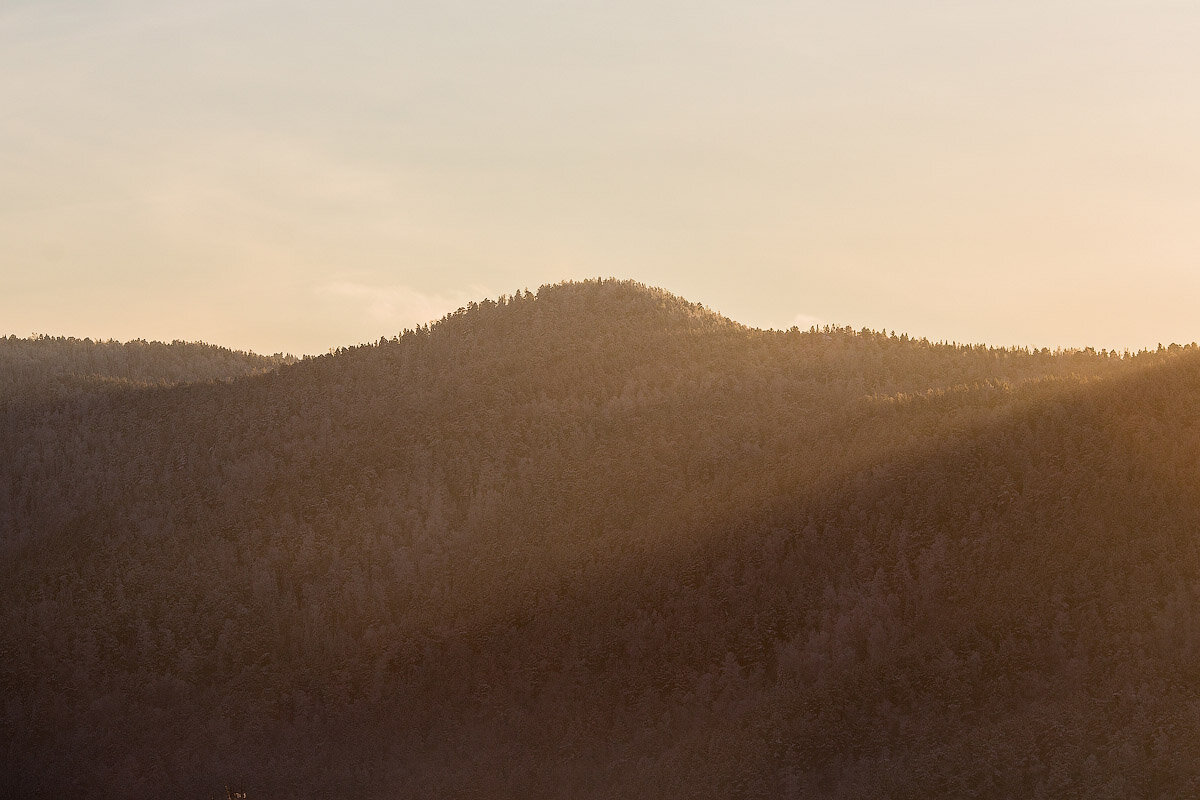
(0, 0, 1200, 354)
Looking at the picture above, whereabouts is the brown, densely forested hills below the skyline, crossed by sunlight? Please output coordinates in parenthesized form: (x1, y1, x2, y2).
(0, 281, 1200, 799)
